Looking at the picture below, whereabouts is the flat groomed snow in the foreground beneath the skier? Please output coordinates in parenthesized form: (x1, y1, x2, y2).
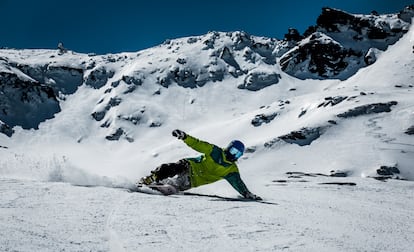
(0, 177, 414, 252)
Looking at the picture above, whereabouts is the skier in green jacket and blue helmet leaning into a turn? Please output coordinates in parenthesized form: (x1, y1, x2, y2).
(138, 129, 262, 200)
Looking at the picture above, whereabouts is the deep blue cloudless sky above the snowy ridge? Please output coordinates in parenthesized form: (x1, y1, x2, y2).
(0, 0, 414, 54)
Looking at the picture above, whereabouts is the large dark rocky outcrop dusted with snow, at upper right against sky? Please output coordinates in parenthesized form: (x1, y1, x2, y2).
(280, 7, 414, 79)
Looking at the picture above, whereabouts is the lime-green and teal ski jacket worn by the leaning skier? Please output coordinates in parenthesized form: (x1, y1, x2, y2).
(184, 135, 249, 196)
